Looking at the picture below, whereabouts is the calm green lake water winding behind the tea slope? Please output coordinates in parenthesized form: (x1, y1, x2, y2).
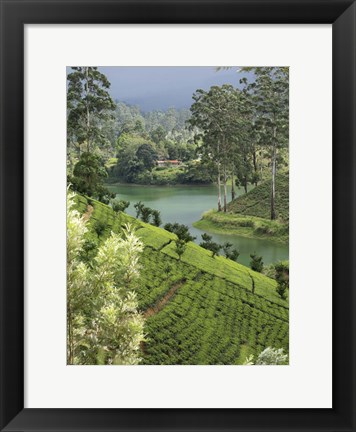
(108, 184, 289, 265)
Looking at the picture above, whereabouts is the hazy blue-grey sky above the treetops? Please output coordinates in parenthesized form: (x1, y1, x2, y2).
(99, 66, 248, 111)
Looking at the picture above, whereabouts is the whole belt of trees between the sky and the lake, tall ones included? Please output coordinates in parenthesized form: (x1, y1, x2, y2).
(68, 67, 289, 211)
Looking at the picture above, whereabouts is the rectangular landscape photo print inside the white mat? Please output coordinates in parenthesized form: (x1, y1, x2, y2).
(66, 66, 289, 366)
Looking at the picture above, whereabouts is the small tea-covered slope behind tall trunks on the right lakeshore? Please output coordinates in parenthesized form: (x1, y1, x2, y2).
(228, 171, 289, 221)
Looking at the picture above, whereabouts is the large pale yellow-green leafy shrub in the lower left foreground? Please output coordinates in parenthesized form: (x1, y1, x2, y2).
(67, 193, 144, 365)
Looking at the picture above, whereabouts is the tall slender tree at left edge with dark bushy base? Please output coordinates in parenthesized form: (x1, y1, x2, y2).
(67, 67, 115, 201)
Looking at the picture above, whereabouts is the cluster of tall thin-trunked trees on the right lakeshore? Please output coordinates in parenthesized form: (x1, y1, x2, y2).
(189, 67, 289, 220)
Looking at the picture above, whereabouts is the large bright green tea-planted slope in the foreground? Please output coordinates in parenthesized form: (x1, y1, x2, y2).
(73, 196, 289, 364)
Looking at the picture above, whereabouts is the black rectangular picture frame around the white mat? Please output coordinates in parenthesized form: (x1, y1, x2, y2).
(0, 0, 356, 432)
